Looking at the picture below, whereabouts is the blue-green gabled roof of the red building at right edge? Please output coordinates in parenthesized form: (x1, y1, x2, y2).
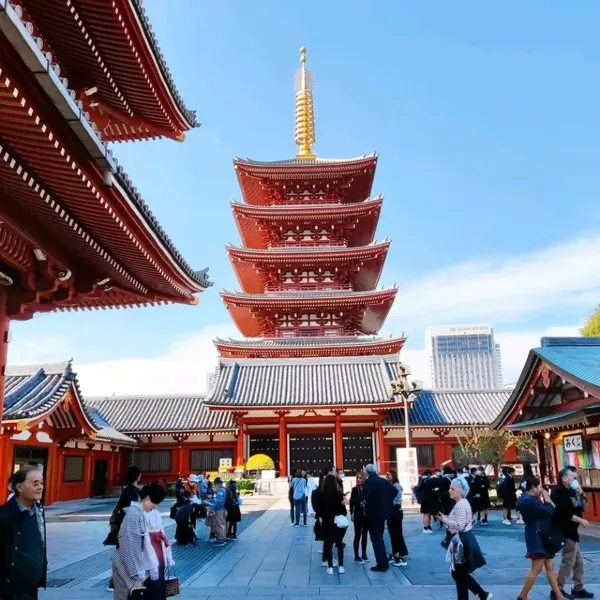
(494, 337, 600, 429)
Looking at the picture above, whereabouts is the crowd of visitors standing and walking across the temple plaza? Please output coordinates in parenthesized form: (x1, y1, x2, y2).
(0, 465, 594, 600)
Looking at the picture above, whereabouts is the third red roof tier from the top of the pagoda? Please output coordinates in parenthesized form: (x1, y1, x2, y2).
(227, 240, 390, 294)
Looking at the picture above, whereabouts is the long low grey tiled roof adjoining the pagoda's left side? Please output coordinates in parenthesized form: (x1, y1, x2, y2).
(86, 395, 236, 435)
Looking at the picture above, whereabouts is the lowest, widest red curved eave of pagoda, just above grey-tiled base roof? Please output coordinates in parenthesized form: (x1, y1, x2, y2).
(215, 338, 406, 359)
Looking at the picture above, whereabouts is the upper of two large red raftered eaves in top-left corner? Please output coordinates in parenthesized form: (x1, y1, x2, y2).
(11, 0, 198, 141)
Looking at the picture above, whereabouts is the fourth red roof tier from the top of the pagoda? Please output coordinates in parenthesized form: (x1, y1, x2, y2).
(221, 287, 398, 337)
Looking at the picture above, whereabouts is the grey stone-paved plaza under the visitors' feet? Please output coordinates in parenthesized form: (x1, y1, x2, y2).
(41, 497, 600, 600)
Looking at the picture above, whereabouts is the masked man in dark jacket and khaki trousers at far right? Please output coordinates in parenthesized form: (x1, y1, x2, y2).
(550, 468, 594, 598)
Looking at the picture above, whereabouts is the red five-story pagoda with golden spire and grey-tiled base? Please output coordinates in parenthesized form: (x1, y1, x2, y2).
(207, 48, 405, 475)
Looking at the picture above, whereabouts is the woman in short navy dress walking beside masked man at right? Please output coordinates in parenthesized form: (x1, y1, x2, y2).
(517, 476, 564, 600)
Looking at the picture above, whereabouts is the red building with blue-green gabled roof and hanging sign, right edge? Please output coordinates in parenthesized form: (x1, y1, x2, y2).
(494, 337, 600, 521)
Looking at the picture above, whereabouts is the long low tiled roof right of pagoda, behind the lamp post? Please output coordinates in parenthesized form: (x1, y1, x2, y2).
(384, 390, 510, 427)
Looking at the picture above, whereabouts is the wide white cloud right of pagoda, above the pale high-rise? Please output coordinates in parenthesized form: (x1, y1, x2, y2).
(392, 233, 600, 325)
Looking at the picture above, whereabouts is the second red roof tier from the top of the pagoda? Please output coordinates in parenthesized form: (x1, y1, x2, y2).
(231, 196, 383, 248)
